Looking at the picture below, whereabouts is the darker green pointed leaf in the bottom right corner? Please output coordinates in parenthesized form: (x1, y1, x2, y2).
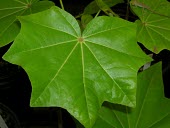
(93, 63, 170, 128)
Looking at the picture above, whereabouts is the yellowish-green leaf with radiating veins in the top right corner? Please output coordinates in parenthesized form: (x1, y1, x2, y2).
(131, 0, 170, 53)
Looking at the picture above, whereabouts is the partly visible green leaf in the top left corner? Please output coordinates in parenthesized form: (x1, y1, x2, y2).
(0, 0, 54, 47)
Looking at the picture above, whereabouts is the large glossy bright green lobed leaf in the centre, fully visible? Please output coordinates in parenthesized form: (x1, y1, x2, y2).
(3, 7, 150, 128)
